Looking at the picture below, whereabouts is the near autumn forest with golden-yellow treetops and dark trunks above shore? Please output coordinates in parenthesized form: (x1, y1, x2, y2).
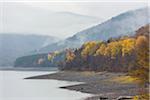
(60, 25, 149, 76)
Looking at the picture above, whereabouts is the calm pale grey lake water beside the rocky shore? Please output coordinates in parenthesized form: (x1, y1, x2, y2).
(0, 71, 91, 100)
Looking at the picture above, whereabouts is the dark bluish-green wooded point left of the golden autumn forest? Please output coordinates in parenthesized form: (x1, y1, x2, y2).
(14, 51, 66, 68)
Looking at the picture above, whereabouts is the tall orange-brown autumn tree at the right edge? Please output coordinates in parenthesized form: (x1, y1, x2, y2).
(132, 36, 149, 84)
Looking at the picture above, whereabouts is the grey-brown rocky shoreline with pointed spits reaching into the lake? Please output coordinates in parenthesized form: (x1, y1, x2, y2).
(25, 71, 143, 100)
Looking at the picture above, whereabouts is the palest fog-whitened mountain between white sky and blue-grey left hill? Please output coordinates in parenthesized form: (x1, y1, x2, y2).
(0, 3, 101, 38)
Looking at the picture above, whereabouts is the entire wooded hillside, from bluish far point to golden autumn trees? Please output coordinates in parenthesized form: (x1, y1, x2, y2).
(15, 25, 149, 72)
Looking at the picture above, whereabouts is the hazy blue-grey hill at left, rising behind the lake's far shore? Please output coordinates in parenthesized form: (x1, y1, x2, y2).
(0, 34, 58, 66)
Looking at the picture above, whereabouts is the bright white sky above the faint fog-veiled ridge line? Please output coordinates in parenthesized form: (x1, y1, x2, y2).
(26, 2, 147, 19)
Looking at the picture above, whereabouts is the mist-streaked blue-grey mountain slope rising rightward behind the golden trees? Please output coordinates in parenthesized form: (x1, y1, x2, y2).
(37, 8, 150, 53)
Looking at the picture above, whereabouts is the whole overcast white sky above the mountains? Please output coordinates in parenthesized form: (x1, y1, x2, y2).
(0, 0, 148, 37)
